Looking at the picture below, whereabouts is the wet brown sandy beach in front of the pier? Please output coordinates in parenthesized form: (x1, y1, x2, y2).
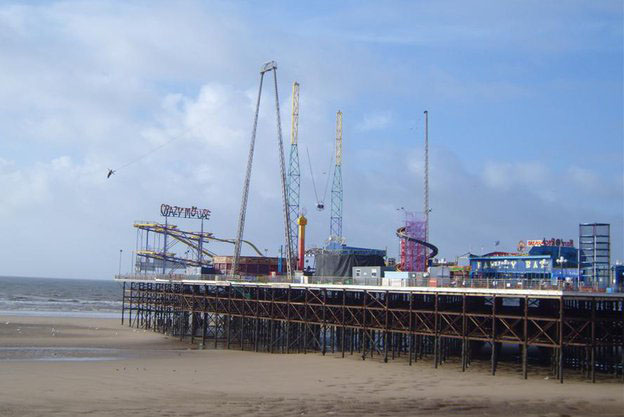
(0, 316, 624, 417)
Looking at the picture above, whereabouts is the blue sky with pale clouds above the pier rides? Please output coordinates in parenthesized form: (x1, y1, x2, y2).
(0, 0, 624, 279)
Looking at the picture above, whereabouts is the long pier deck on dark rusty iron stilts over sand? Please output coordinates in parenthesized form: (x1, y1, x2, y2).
(116, 276, 624, 382)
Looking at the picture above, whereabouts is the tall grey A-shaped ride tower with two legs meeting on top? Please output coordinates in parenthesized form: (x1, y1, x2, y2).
(232, 61, 293, 278)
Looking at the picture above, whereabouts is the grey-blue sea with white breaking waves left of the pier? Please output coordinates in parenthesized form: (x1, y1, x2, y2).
(0, 276, 121, 317)
